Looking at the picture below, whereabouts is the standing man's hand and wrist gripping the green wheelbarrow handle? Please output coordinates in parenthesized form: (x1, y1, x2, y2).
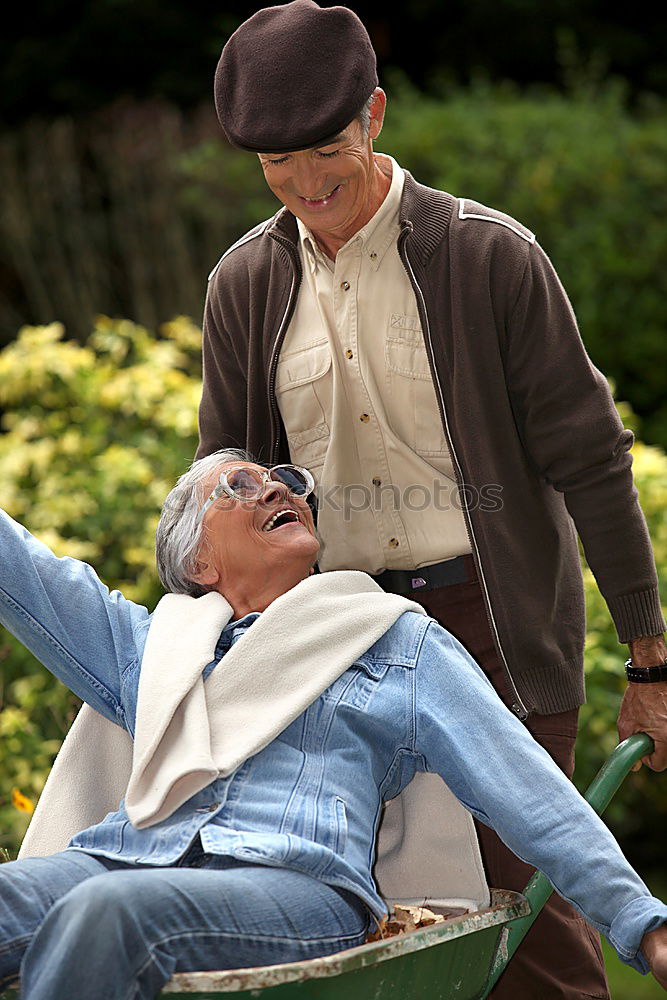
(618, 635, 667, 771)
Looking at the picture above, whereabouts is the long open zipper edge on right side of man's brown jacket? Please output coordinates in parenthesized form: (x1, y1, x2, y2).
(398, 222, 528, 720)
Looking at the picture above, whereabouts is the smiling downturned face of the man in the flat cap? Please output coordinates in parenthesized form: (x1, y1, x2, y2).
(258, 88, 385, 249)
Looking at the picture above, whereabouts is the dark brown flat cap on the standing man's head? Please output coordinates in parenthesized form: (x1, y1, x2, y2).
(215, 0, 378, 153)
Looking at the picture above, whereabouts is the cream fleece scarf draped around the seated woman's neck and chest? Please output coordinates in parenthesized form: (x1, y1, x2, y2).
(125, 570, 425, 829)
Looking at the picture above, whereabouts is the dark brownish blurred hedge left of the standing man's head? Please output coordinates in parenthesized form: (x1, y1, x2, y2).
(0, 102, 275, 343)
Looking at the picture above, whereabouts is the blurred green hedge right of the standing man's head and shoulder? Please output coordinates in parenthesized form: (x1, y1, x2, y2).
(376, 77, 667, 447)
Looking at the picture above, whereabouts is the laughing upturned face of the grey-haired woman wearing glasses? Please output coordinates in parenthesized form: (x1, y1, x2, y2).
(196, 462, 319, 611)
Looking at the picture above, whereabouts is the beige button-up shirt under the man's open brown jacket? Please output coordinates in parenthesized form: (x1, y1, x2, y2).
(276, 148, 471, 573)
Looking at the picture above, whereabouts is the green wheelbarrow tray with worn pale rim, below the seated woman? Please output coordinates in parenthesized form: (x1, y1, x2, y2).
(159, 889, 529, 1000)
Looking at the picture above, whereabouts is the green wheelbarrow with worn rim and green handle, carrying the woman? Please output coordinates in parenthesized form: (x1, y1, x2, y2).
(0, 733, 653, 1000)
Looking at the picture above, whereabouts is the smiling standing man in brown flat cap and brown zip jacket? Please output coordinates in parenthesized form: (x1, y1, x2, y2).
(197, 0, 667, 1000)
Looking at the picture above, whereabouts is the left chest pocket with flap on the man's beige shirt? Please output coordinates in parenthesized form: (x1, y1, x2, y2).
(276, 340, 332, 470)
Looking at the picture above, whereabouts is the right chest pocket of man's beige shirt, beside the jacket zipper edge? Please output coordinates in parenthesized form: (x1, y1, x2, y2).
(384, 314, 447, 458)
